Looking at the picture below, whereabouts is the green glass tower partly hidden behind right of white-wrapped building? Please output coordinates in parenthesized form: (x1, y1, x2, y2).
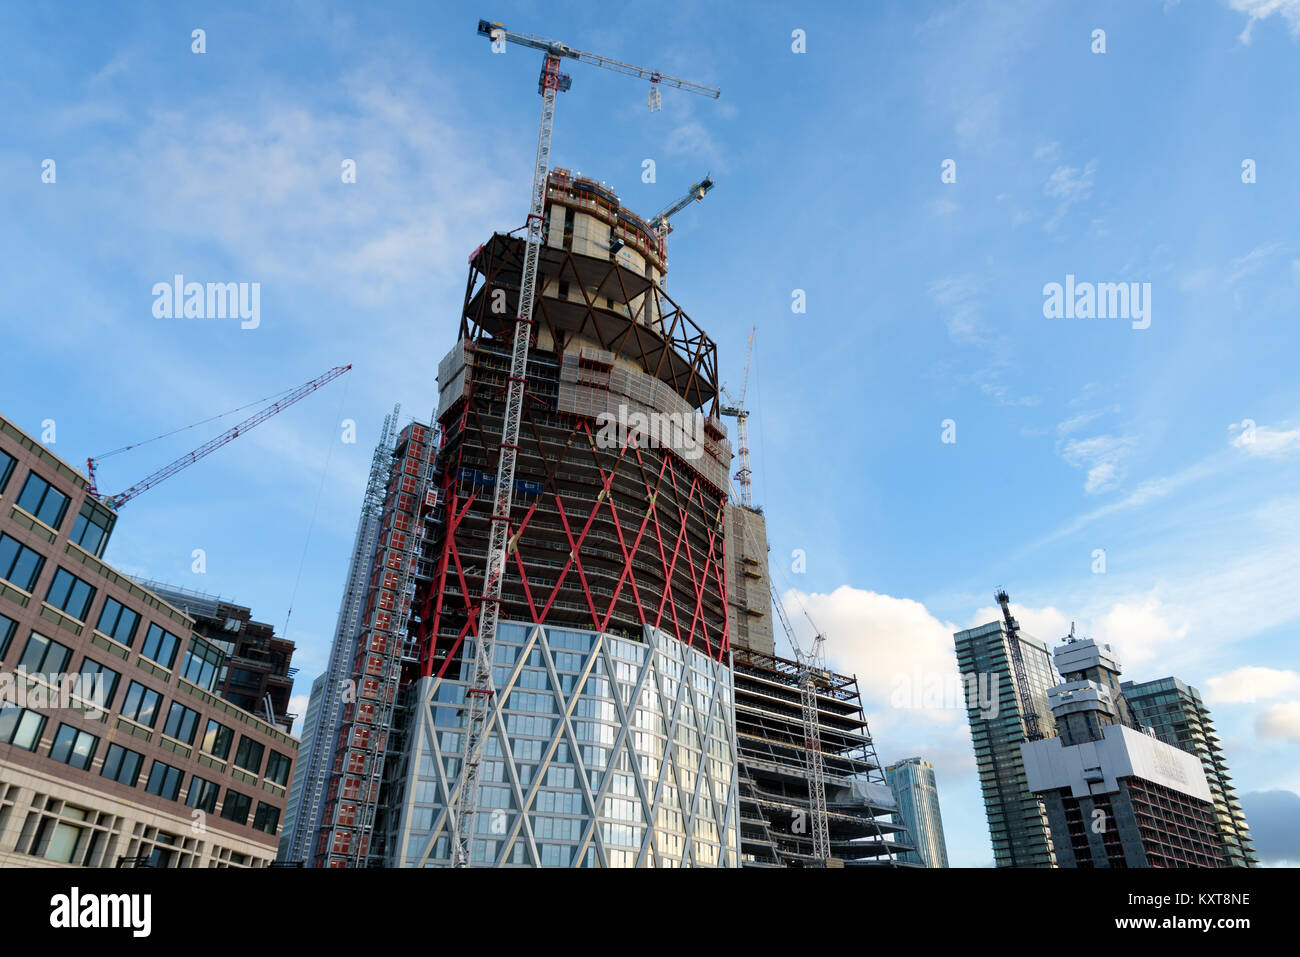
(1122, 677, 1258, 867)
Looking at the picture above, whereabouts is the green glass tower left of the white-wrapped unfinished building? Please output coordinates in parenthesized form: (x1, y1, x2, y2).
(953, 620, 1056, 867)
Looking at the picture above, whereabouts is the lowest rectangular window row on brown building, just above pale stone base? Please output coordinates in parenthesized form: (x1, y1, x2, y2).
(0, 707, 287, 835)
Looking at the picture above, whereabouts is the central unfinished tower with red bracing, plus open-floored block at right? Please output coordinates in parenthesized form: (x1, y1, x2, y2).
(286, 169, 905, 867)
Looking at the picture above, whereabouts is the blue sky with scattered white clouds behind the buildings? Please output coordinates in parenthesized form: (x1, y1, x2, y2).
(0, 0, 1300, 866)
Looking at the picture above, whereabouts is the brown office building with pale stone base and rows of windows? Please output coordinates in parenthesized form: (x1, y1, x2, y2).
(0, 417, 298, 867)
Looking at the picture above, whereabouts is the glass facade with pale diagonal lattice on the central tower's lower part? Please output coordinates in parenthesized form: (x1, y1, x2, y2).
(389, 623, 740, 867)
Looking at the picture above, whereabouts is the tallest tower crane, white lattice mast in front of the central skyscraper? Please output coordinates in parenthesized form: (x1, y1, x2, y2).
(451, 20, 722, 867)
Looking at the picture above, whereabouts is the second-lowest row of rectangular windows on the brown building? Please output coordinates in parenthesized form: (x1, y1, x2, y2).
(0, 615, 291, 787)
